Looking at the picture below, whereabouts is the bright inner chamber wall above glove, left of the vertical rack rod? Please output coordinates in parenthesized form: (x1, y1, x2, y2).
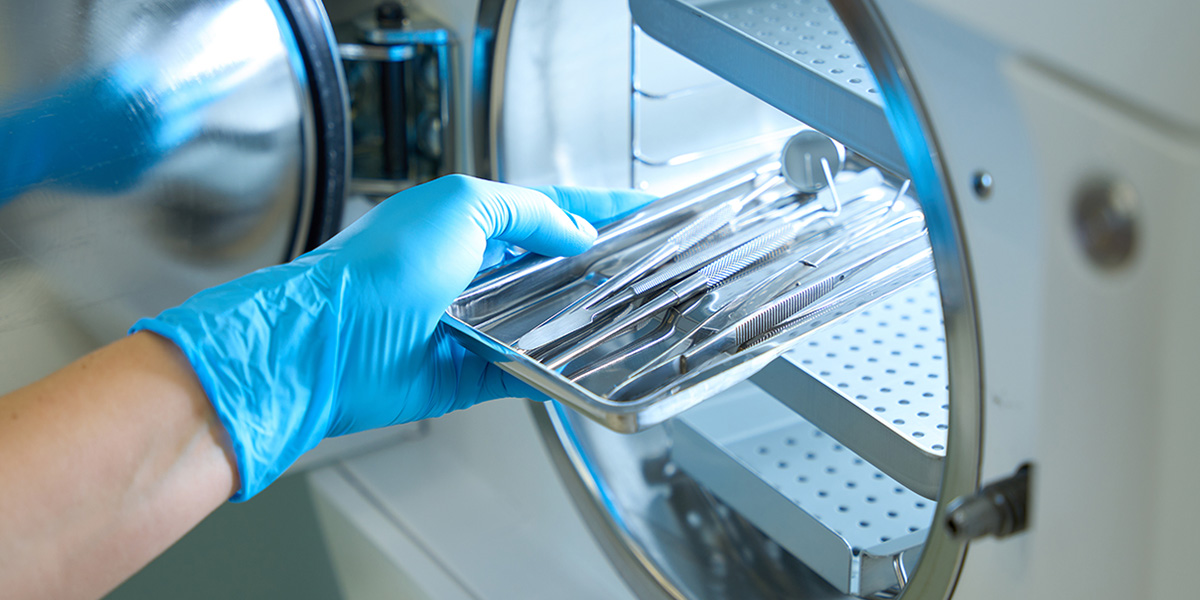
(475, 0, 631, 187)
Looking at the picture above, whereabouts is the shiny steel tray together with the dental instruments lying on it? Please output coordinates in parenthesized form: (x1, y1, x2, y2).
(443, 156, 936, 432)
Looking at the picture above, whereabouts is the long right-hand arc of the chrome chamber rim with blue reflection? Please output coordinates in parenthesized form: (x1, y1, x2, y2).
(830, 0, 984, 599)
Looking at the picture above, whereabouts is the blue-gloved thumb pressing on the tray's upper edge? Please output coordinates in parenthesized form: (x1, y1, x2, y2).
(473, 175, 596, 256)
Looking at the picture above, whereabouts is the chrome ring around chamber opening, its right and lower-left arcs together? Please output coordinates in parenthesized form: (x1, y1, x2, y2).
(520, 0, 983, 599)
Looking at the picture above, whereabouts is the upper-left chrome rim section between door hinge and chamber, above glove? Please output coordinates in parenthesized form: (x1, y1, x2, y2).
(468, 0, 517, 180)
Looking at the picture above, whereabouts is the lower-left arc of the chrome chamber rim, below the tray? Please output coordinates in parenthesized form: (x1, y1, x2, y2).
(529, 402, 688, 600)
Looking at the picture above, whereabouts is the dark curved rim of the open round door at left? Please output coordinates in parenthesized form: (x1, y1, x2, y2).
(270, 0, 350, 253)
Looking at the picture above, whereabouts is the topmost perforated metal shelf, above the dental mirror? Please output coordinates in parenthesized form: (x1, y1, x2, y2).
(630, 0, 907, 175)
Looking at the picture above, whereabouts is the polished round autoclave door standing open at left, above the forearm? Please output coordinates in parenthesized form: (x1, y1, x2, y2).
(0, 0, 346, 389)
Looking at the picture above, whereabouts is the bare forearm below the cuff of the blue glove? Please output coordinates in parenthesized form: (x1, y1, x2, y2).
(0, 332, 238, 598)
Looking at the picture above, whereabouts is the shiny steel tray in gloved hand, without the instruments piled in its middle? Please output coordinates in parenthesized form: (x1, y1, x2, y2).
(443, 157, 932, 432)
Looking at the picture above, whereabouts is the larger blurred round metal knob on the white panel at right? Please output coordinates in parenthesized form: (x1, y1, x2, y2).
(1073, 179, 1139, 269)
